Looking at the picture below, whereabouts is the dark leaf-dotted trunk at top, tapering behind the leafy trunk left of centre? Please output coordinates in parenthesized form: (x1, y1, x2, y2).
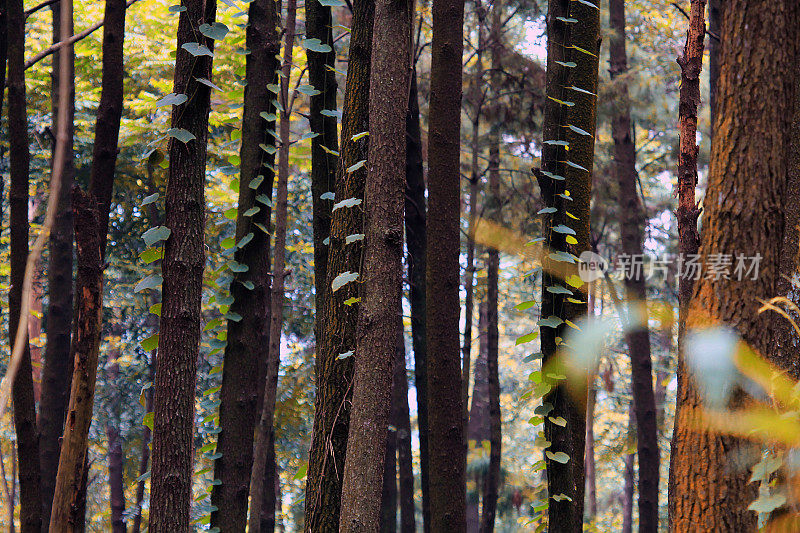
(305, 2, 339, 306)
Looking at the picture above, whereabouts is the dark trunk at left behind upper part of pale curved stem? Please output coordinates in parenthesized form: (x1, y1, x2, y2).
(38, 2, 75, 531)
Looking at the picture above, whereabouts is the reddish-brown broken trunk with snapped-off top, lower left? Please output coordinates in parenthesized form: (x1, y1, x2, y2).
(49, 186, 103, 533)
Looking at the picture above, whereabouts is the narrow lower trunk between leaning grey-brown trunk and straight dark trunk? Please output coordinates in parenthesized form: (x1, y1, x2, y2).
(392, 318, 417, 533)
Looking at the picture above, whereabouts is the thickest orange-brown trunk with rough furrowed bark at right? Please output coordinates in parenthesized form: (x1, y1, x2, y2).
(670, 0, 800, 532)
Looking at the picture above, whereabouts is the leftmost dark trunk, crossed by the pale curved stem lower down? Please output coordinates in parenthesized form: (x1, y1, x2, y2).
(6, 0, 42, 533)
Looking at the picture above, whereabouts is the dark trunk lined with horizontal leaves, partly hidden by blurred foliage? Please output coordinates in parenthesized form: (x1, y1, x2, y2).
(536, 0, 600, 532)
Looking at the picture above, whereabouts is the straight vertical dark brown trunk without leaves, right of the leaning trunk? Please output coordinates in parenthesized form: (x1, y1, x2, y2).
(426, 0, 466, 532)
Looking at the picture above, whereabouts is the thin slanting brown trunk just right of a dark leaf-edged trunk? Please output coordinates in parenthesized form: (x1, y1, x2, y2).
(249, 0, 297, 533)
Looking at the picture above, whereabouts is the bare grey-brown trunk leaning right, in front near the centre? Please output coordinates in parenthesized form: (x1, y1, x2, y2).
(339, 0, 411, 533)
